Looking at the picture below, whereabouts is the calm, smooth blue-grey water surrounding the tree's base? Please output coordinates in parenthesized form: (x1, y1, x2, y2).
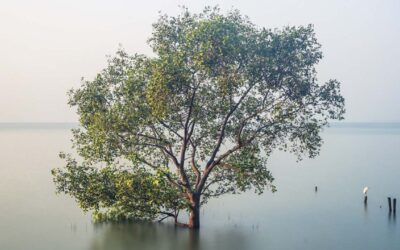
(0, 124, 400, 250)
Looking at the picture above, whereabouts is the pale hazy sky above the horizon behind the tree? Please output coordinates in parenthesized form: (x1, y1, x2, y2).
(0, 0, 400, 122)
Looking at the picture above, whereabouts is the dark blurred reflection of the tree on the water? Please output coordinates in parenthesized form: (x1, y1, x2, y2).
(90, 222, 246, 250)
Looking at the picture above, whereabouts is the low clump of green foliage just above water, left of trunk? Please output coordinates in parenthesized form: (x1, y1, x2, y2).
(52, 154, 187, 221)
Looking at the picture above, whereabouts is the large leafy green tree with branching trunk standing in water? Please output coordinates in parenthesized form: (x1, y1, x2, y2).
(53, 8, 344, 228)
